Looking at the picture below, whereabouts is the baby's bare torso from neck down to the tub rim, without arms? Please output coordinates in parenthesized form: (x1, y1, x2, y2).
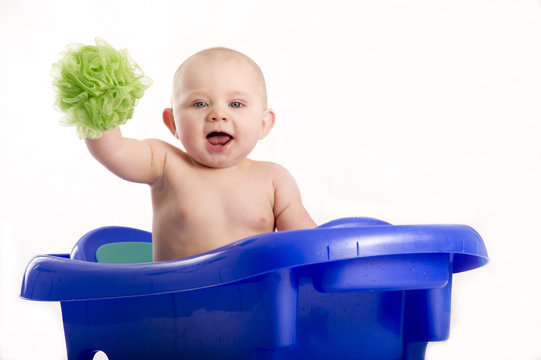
(152, 148, 275, 260)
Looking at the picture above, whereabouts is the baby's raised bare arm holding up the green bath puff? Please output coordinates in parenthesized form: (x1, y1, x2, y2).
(85, 126, 165, 184)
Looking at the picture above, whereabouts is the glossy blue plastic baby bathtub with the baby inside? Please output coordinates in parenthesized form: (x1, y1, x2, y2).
(21, 218, 488, 360)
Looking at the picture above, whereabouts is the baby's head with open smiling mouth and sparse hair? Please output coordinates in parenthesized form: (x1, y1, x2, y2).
(163, 48, 274, 168)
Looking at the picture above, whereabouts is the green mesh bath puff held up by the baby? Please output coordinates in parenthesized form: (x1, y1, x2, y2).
(53, 38, 152, 139)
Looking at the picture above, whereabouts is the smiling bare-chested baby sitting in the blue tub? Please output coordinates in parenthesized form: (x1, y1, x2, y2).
(86, 48, 316, 261)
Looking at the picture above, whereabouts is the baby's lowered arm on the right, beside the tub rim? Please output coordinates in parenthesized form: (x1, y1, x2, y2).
(274, 166, 317, 231)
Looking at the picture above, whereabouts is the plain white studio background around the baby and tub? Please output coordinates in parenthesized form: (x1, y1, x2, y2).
(0, 0, 541, 360)
